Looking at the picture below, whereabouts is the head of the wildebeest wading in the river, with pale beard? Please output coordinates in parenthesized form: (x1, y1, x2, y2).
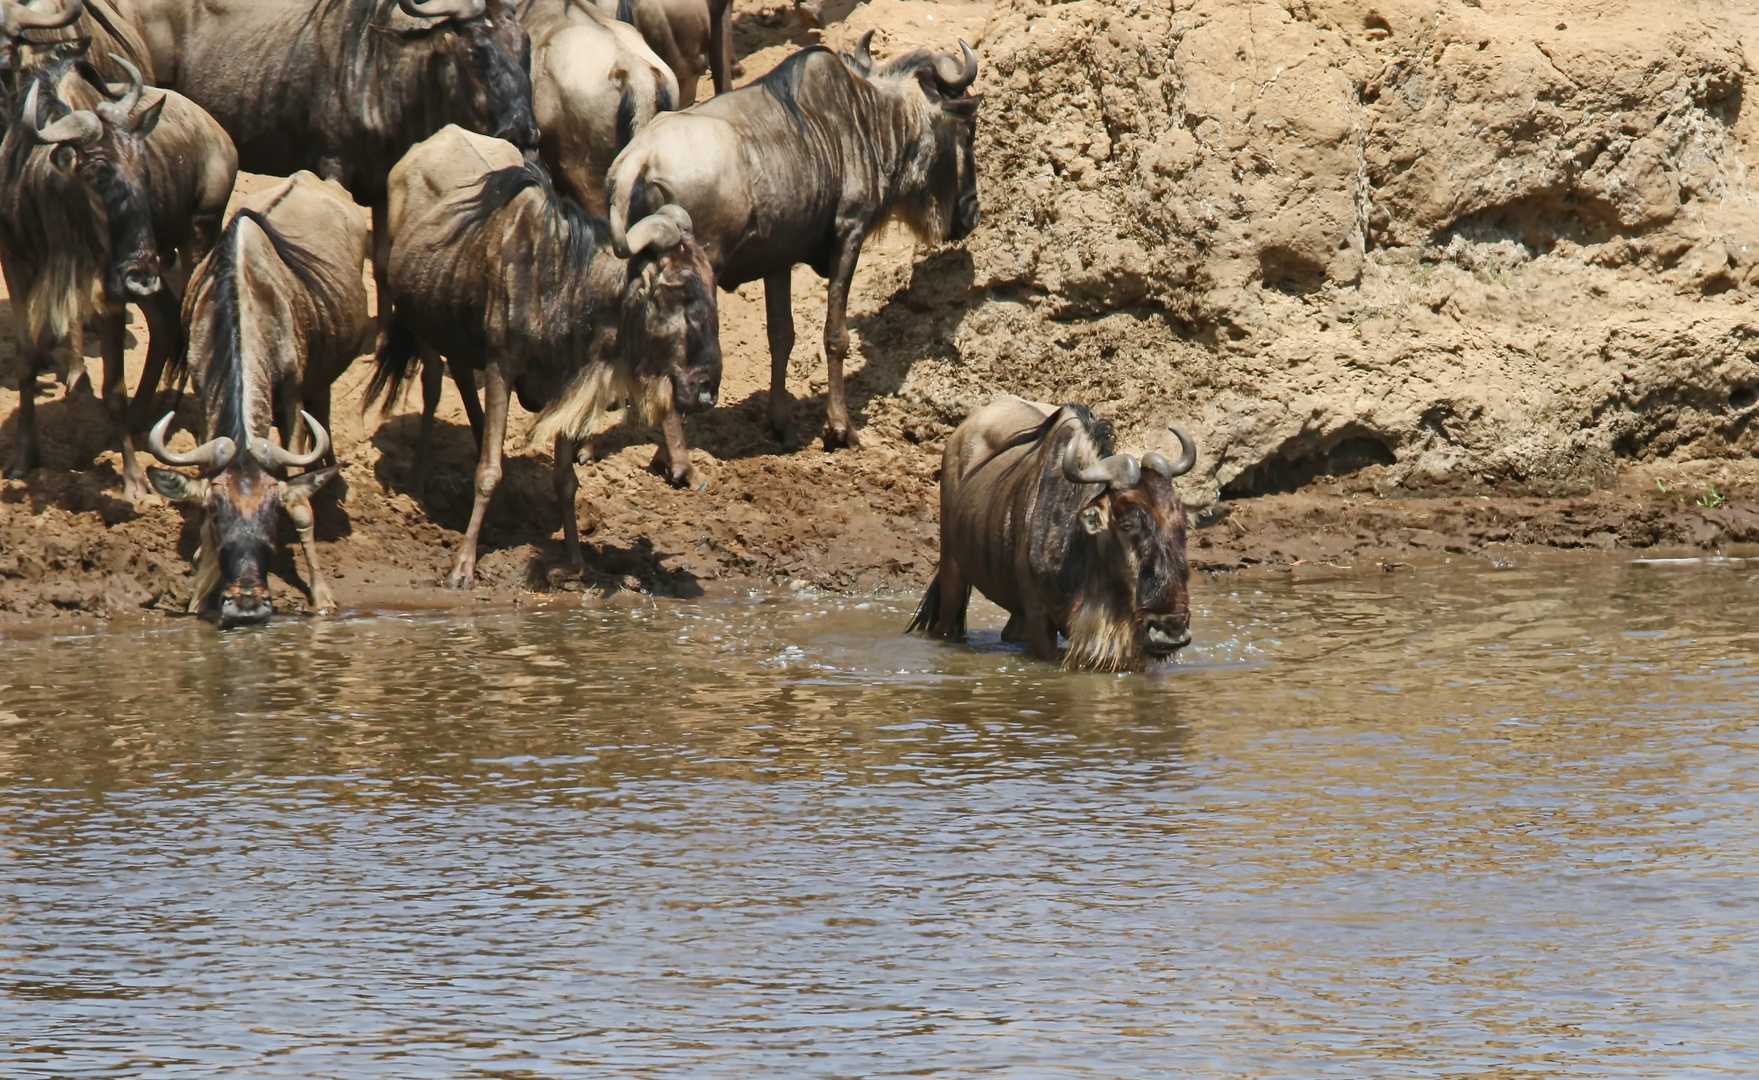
(1062, 426, 1196, 668)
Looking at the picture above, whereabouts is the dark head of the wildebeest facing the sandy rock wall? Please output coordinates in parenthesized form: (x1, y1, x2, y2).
(848, 30, 983, 243)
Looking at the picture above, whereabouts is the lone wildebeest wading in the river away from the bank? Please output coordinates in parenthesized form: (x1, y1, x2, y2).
(909, 396, 1196, 670)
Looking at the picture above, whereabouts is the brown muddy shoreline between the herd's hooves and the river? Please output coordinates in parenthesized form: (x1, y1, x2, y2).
(0, 378, 1759, 628)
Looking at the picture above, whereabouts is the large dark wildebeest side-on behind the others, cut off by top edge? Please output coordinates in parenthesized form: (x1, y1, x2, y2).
(125, 0, 538, 337)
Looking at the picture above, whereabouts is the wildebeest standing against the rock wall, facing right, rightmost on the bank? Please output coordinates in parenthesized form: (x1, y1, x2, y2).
(607, 37, 982, 449)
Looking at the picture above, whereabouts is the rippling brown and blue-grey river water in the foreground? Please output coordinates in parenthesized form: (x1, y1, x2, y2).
(0, 561, 1759, 1078)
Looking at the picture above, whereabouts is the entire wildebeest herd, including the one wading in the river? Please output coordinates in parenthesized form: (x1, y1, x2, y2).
(0, 0, 1194, 668)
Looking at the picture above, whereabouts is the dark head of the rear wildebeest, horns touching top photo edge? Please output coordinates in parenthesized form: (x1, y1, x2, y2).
(396, 0, 538, 151)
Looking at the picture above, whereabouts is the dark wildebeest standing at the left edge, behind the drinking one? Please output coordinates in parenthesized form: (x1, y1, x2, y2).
(0, 55, 237, 501)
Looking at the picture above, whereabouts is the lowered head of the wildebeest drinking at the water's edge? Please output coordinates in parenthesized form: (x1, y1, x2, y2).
(146, 412, 341, 628)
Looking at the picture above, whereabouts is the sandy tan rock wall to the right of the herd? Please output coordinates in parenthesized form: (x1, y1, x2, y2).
(858, 0, 1759, 494)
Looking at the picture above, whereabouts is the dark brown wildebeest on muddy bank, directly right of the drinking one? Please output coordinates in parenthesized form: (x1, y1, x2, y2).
(368, 127, 721, 587)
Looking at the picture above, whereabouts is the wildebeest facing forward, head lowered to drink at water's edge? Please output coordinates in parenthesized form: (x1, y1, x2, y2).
(148, 172, 368, 626)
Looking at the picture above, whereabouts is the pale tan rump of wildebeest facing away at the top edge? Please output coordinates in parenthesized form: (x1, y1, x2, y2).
(519, 0, 679, 215)
